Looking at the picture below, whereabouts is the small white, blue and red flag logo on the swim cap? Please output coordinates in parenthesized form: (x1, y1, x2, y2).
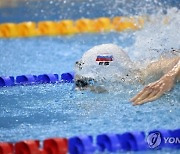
(96, 55, 113, 65)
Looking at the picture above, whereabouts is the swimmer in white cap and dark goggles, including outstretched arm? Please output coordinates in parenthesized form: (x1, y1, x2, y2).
(75, 44, 180, 105)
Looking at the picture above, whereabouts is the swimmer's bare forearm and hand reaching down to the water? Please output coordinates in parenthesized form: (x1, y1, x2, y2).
(130, 58, 180, 105)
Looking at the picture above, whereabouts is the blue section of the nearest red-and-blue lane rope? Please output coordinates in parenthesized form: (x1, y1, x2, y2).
(68, 129, 180, 154)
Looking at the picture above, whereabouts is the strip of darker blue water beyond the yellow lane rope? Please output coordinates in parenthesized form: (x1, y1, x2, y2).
(0, 0, 180, 23)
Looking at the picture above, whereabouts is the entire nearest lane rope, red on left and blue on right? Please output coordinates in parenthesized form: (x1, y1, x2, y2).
(0, 129, 180, 154)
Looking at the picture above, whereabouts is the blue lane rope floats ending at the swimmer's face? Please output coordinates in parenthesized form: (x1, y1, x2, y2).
(0, 72, 75, 87)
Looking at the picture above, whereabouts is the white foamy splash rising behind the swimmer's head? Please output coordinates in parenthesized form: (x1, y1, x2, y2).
(126, 8, 180, 63)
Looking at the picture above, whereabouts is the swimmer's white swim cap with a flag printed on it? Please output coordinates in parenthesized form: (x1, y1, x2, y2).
(76, 44, 135, 82)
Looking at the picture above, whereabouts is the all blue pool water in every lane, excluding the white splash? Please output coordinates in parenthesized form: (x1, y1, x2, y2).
(0, 0, 180, 154)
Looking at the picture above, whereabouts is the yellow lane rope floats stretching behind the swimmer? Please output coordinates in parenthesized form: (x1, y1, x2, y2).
(0, 17, 145, 38)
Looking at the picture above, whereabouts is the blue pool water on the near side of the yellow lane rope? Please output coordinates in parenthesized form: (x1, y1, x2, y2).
(0, 0, 180, 153)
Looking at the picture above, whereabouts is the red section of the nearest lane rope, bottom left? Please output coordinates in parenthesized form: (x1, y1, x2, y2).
(0, 138, 68, 154)
